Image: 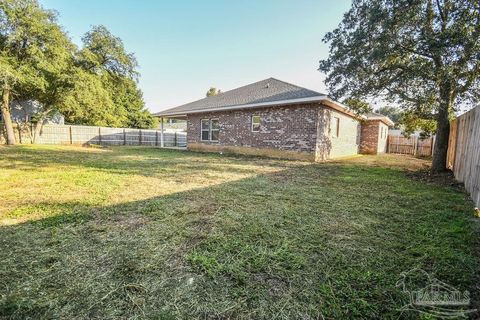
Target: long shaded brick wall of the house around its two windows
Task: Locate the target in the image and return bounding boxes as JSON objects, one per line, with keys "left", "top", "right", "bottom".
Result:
{"left": 187, "top": 104, "right": 319, "bottom": 153}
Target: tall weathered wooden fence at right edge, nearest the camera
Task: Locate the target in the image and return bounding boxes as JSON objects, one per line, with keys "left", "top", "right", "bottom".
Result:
{"left": 447, "top": 106, "right": 480, "bottom": 207}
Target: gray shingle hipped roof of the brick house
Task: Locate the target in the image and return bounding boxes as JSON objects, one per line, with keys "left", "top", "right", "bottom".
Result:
{"left": 154, "top": 78, "right": 325, "bottom": 116}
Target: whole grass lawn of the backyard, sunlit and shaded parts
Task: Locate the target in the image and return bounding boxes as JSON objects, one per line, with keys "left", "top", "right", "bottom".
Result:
{"left": 0, "top": 146, "right": 480, "bottom": 319}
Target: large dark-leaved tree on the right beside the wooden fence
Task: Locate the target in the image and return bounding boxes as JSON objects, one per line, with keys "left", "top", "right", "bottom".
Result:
{"left": 319, "top": 0, "right": 480, "bottom": 172}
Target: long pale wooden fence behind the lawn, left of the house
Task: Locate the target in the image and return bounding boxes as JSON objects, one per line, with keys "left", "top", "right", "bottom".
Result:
{"left": 0, "top": 125, "right": 187, "bottom": 147}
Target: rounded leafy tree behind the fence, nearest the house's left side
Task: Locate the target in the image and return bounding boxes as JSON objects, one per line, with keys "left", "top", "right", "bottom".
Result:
{"left": 66, "top": 26, "right": 155, "bottom": 128}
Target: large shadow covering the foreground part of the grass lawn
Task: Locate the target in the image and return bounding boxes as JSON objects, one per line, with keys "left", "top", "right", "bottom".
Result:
{"left": 0, "top": 164, "right": 478, "bottom": 319}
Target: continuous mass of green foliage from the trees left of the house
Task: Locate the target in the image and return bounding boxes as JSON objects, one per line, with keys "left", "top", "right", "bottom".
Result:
{"left": 0, "top": 0, "right": 155, "bottom": 128}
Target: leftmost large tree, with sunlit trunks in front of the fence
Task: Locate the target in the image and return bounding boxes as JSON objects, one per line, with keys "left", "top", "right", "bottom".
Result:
{"left": 0, "top": 0, "right": 75, "bottom": 143}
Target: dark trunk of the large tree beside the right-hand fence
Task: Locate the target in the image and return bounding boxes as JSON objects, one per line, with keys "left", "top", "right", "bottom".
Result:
{"left": 432, "top": 88, "right": 453, "bottom": 173}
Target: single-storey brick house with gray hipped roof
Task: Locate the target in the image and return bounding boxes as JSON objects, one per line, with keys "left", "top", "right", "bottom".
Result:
{"left": 154, "top": 78, "right": 393, "bottom": 161}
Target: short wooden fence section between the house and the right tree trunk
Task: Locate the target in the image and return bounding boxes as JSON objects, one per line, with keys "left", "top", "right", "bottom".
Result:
{"left": 387, "top": 135, "right": 435, "bottom": 156}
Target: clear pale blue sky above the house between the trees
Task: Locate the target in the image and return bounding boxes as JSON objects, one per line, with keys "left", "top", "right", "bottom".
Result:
{"left": 40, "top": 0, "right": 351, "bottom": 112}
